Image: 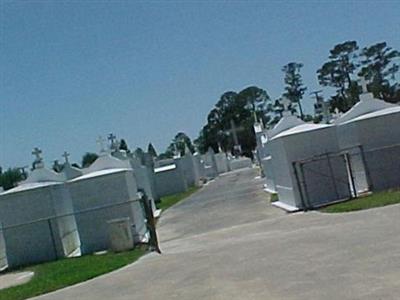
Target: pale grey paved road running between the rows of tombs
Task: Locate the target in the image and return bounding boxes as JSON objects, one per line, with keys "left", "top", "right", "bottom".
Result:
{"left": 32, "top": 170, "right": 400, "bottom": 300}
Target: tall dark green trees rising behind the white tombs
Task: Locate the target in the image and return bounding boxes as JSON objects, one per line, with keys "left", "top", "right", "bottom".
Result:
{"left": 195, "top": 41, "right": 400, "bottom": 157}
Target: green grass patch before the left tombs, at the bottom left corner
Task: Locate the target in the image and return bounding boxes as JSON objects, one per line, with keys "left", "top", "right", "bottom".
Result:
{"left": 0, "top": 249, "right": 146, "bottom": 300}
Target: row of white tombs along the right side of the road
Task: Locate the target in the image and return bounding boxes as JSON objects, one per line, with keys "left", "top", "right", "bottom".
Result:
{"left": 254, "top": 87, "right": 400, "bottom": 211}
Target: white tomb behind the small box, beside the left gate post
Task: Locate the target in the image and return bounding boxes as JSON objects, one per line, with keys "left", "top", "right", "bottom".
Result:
{"left": 68, "top": 152, "right": 148, "bottom": 254}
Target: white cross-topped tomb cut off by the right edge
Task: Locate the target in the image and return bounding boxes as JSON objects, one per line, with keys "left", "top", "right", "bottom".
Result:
{"left": 335, "top": 81, "right": 400, "bottom": 193}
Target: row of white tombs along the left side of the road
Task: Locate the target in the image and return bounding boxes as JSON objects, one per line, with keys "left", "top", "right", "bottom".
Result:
{"left": 0, "top": 144, "right": 252, "bottom": 271}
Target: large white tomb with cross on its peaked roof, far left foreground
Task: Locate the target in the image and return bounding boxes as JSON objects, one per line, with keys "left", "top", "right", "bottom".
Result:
{"left": 0, "top": 149, "right": 80, "bottom": 267}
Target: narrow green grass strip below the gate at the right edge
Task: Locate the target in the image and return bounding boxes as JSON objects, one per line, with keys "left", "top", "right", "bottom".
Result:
{"left": 320, "top": 190, "right": 400, "bottom": 213}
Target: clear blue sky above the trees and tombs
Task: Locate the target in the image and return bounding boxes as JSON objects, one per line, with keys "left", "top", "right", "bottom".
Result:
{"left": 0, "top": 1, "right": 400, "bottom": 167}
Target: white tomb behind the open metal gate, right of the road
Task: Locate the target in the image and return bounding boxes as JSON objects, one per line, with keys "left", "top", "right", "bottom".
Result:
{"left": 269, "top": 124, "right": 349, "bottom": 209}
